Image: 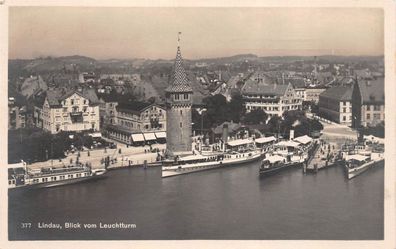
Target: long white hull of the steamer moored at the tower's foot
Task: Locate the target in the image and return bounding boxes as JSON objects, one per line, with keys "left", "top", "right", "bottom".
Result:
{"left": 162, "top": 153, "right": 261, "bottom": 178}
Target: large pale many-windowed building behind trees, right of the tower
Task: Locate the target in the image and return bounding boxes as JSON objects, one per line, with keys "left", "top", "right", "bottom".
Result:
{"left": 242, "top": 74, "right": 302, "bottom": 117}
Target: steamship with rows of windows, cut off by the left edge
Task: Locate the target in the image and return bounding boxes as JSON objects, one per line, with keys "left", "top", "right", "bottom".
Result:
{"left": 8, "top": 161, "right": 106, "bottom": 190}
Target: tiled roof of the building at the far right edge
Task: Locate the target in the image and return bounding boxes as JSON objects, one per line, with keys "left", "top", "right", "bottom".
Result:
{"left": 358, "top": 78, "right": 385, "bottom": 104}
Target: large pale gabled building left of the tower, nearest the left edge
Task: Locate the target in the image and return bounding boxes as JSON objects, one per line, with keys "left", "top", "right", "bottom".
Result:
{"left": 33, "top": 88, "right": 100, "bottom": 134}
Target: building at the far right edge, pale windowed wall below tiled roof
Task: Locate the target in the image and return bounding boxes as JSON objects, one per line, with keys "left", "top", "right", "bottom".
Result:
{"left": 359, "top": 77, "right": 385, "bottom": 126}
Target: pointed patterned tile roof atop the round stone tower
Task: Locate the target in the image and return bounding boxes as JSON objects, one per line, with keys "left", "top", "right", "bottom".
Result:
{"left": 165, "top": 46, "right": 193, "bottom": 92}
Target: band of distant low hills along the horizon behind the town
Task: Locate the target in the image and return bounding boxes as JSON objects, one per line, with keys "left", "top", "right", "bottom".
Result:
{"left": 9, "top": 54, "right": 384, "bottom": 75}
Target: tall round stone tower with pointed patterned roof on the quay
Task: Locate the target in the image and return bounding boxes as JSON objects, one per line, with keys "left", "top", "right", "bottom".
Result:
{"left": 165, "top": 42, "right": 193, "bottom": 156}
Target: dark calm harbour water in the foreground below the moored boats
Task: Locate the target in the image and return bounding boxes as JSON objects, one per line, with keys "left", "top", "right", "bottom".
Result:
{"left": 8, "top": 163, "right": 384, "bottom": 240}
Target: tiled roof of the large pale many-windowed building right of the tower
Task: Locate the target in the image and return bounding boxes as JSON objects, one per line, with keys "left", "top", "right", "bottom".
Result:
{"left": 242, "top": 79, "right": 289, "bottom": 96}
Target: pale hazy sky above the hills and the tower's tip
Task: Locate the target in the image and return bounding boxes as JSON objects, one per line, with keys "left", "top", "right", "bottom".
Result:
{"left": 9, "top": 7, "right": 384, "bottom": 59}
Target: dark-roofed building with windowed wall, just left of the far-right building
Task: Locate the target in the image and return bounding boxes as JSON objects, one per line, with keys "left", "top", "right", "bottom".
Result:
{"left": 318, "top": 86, "right": 352, "bottom": 126}
